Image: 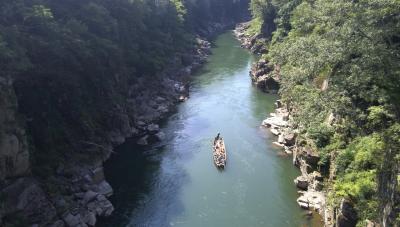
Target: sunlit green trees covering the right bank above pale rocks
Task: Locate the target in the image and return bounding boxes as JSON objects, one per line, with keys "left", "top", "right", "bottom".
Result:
{"left": 250, "top": 0, "right": 400, "bottom": 226}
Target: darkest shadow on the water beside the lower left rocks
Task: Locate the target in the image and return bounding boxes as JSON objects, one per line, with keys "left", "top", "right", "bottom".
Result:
{"left": 98, "top": 140, "right": 161, "bottom": 227}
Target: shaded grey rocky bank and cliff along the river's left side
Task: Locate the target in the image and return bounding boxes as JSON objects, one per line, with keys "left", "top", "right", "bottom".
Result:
{"left": 0, "top": 38, "right": 210, "bottom": 226}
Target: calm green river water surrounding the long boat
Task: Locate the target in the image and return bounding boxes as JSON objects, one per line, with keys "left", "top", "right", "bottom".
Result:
{"left": 101, "top": 32, "right": 321, "bottom": 227}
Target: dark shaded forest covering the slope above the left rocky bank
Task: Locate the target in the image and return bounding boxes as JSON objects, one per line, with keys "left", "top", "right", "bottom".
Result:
{"left": 0, "top": 0, "right": 246, "bottom": 174}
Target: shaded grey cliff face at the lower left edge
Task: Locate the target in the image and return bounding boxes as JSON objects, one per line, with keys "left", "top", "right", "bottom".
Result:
{"left": 0, "top": 76, "right": 56, "bottom": 226}
